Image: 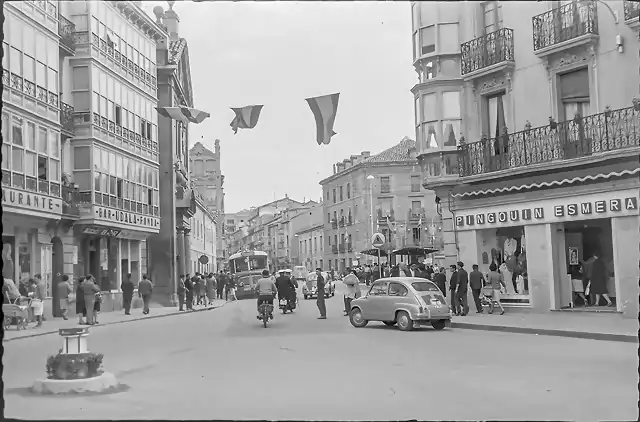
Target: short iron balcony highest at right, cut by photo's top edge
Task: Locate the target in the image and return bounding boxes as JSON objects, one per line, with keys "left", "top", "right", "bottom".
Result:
{"left": 532, "top": 0, "right": 598, "bottom": 56}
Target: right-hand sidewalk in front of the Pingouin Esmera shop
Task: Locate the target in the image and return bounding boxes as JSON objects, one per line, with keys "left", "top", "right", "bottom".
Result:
{"left": 360, "top": 283, "right": 639, "bottom": 343}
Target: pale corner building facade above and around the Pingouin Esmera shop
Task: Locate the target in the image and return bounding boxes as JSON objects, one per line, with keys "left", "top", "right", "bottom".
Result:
{"left": 412, "top": 0, "right": 640, "bottom": 318}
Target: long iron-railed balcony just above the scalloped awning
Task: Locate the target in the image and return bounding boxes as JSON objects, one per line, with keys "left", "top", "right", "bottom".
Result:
{"left": 458, "top": 107, "right": 640, "bottom": 177}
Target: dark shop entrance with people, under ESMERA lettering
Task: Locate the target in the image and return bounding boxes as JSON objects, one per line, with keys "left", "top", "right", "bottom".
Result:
{"left": 563, "top": 218, "right": 616, "bottom": 312}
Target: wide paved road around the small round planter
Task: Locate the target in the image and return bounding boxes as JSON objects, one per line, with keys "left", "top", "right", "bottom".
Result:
{"left": 3, "top": 297, "right": 638, "bottom": 421}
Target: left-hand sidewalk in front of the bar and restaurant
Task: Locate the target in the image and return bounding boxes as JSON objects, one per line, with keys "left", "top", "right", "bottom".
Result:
{"left": 3, "top": 299, "right": 226, "bottom": 342}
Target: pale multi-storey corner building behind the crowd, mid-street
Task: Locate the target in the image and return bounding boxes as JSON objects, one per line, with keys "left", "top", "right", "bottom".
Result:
{"left": 320, "top": 137, "right": 440, "bottom": 271}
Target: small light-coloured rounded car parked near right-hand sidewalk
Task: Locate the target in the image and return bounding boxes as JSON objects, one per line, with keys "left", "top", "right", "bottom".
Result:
{"left": 349, "top": 277, "right": 452, "bottom": 331}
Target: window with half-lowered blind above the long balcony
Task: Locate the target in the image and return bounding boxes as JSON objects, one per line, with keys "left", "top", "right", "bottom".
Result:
{"left": 558, "top": 68, "right": 590, "bottom": 121}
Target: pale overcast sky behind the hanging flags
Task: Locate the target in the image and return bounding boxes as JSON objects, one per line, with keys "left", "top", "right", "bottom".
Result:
{"left": 144, "top": 1, "right": 417, "bottom": 213}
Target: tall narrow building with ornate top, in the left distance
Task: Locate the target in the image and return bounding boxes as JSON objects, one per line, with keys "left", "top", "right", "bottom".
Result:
{"left": 189, "top": 139, "right": 227, "bottom": 265}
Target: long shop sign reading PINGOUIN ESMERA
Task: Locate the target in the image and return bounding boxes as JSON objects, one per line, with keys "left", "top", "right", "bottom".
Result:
{"left": 455, "top": 192, "right": 638, "bottom": 229}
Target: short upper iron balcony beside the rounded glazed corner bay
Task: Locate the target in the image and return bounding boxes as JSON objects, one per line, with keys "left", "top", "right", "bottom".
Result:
{"left": 460, "top": 28, "right": 515, "bottom": 80}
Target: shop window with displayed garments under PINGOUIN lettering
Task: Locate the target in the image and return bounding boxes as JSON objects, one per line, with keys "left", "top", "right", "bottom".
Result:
{"left": 478, "top": 226, "right": 529, "bottom": 304}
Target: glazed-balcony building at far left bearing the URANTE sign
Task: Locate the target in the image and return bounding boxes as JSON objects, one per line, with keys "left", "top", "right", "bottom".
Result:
{"left": 2, "top": 2, "right": 79, "bottom": 316}
